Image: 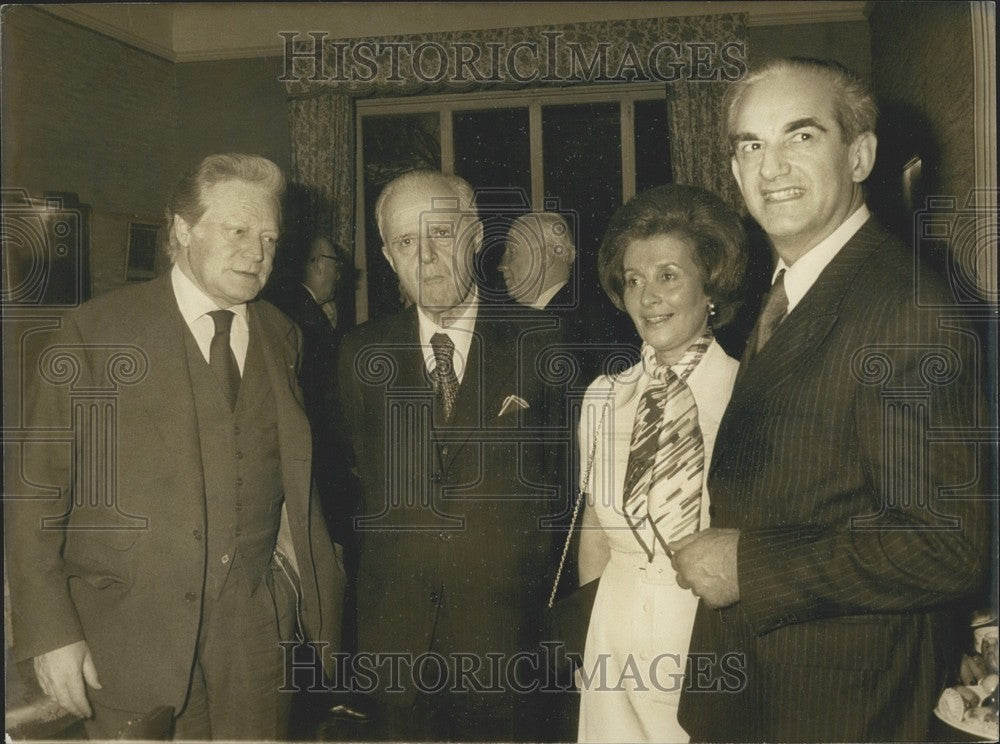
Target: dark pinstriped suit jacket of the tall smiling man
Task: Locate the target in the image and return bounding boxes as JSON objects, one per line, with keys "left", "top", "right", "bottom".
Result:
{"left": 680, "top": 218, "right": 989, "bottom": 741}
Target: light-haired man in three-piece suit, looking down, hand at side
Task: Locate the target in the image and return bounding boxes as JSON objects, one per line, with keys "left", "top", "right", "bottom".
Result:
{"left": 5, "top": 154, "right": 344, "bottom": 739}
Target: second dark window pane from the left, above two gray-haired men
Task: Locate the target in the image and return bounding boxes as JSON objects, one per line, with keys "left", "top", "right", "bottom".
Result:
{"left": 452, "top": 107, "right": 531, "bottom": 296}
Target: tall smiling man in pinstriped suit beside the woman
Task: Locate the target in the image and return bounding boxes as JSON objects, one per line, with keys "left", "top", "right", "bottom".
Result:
{"left": 671, "top": 59, "right": 989, "bottom": 741}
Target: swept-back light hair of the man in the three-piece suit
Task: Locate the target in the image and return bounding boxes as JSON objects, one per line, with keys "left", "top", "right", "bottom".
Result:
{"left": 166, "top": 152, "right": 285, "bottom": 262}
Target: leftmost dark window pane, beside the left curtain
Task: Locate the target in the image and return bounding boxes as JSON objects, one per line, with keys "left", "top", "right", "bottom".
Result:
{"left": 361, "top": 112, "right": 441, "bottom": 318}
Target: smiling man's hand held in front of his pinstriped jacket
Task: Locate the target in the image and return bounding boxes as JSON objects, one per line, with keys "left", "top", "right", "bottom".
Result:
{"left": 667, "top": 527, "right": 740, "bottom": 609}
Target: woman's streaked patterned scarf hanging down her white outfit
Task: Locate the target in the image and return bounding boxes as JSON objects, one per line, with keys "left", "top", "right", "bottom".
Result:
{"left": 623, "top": 335, "right": 712, "bottom": 560}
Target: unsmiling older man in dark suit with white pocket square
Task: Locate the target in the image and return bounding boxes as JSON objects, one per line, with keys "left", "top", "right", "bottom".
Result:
{"left": 339, "top": 171, "right": 567, "bottom": 741}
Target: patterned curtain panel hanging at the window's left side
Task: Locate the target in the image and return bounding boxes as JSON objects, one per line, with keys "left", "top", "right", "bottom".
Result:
{"left": 289, "top": 93, "right": 355, "bottom": 250}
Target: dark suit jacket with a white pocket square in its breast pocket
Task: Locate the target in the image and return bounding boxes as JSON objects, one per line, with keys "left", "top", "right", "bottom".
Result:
{"left": 339, "top": 305, "right": 572, "bottom": 705}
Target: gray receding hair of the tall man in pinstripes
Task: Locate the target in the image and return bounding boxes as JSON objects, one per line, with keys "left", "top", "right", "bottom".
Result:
{"left": 722, "top": 57, "right": 878, "bottom": 147}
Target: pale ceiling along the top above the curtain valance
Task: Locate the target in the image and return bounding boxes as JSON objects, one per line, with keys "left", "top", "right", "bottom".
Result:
{"left": 36, "top": 0, "right": 867, "bottom": 62}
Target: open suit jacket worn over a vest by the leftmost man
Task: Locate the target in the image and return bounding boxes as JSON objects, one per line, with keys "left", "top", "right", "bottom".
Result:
{"left": 5, "top": 275, "right": 344, "bottom": 710}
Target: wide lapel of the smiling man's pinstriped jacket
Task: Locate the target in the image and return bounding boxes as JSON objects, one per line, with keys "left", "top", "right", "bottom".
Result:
{"left": 733, "top": 218, "right": 885, "bottom": 398}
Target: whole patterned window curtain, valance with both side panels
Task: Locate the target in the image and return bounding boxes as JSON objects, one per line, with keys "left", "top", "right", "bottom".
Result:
{"left": 282, "top": 14, "right": 749, "bottom": 296}
